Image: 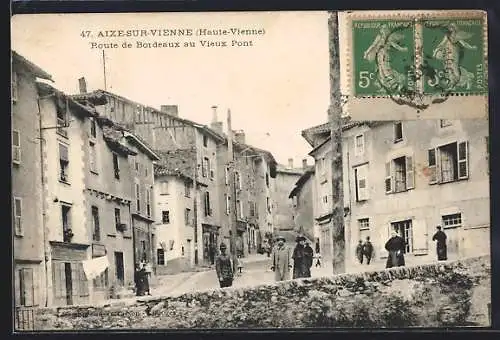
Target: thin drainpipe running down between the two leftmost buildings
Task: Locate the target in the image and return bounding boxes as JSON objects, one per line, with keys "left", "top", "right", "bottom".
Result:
{"left": 37, "top": 93, "right": 54, "bottom": 307}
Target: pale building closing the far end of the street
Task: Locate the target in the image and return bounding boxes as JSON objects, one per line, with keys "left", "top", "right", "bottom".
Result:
{"left": 270, "top": 158, "right": 304, "bottom": 231}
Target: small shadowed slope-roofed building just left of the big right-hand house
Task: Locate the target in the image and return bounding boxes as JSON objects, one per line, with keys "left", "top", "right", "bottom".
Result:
{"left": 288, "top": 160, "right": 319, "bottom": 243}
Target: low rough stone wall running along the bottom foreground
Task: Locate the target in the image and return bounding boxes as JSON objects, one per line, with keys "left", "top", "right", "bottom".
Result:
{"left": 35, "top": 257, "right": 490, "bottom": 330}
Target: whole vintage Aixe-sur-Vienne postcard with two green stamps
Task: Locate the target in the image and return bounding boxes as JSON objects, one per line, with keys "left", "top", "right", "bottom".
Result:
{"left": 11, "top": 11, "right": 491, "bottom": 332}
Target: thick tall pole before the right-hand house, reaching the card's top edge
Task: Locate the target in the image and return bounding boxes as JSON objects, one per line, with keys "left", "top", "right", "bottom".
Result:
{"left": 328, "top": 12, "right": 345, "bottom": 274}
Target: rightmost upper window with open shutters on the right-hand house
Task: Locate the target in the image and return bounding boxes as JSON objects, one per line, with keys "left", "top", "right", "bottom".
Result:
{"left": 428, "top": 142, "right": 469, "bottom": 184}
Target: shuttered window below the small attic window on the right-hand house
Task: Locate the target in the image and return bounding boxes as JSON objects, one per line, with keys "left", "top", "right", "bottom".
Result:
{"left": 385, "top": 156, "right": 415, "bottom": 193}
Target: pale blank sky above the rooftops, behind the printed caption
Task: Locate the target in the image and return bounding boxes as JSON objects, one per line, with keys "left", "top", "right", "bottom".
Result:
{"left": 11, "top": 12, "right": 329, "bottom": 167}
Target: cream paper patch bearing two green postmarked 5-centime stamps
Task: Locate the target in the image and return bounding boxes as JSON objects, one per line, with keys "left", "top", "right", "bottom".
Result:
{"left": 339, "top": 10, "right": 488, "bottom": 119}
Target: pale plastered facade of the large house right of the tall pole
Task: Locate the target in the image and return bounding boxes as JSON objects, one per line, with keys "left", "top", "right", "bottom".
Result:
{"left": 343, "top": 120, "right": 490, "bottom": 267}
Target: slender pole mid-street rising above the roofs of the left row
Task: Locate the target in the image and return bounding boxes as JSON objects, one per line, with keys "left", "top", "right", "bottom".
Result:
{"left": 227, "top": 109, "right": 238, "bottom": 272}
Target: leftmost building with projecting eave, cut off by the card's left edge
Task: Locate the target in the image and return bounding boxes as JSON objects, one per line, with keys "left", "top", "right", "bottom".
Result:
{"left": 11, "top": 52, "right": 52, "bottom": 307}
